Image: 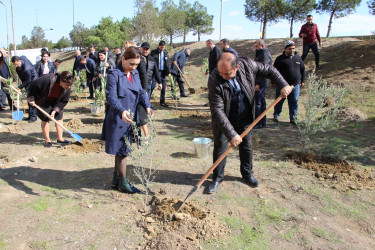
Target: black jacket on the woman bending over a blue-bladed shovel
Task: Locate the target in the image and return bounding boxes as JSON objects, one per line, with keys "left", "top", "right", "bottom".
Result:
{"left": 27, "top": 74, "right": 71, "bottom": 113}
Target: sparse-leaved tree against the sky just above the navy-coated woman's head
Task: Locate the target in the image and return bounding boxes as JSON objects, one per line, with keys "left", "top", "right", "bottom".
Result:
{"left": 133, "top": 0, "right": 161, "bottom": 42}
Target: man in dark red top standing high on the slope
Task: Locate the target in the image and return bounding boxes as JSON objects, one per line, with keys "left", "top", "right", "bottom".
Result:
{"left": 299, "top": 15, "right": 322, "bottom": 69}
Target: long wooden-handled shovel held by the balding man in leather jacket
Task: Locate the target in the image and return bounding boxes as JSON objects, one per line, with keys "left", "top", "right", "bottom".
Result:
{"left": 177, "top": 86, "right": 294, "bottom": 213}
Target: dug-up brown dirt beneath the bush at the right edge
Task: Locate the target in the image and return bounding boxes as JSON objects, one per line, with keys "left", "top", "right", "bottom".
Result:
{"left": 286, "top": 151, "right": 375, "bottom": 191}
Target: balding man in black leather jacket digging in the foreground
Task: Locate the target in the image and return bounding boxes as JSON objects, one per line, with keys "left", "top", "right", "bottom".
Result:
{"left": 208, "top": 52, "right": 292, "bottom": 194}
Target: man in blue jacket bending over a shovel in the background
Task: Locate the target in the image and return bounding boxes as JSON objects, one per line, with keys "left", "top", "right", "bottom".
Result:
{"left": 171, "top": 49, "right": 191, "bottom": 99}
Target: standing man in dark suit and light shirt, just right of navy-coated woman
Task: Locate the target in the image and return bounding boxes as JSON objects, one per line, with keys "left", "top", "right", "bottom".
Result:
{"left": 151, "top": 41, "right": 170, "bottom": 107}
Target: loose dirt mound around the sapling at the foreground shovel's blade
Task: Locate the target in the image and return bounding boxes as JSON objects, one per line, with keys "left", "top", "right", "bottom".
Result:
{"left": 140, "top": 197, "right": 229, "bottom": 249}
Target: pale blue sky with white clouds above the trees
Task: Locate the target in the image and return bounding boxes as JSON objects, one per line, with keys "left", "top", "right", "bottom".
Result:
{"left": 0, "top": 0, "right": 375, "bottom": 47}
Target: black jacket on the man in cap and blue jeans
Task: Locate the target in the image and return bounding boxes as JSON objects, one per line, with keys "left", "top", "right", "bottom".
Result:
{"left": 273, "top": 52, "right": 305, "bottom": 85}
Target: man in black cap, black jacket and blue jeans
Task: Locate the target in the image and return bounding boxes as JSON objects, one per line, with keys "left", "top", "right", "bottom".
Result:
{"left": 273, "top": 40, "right": 305, "bottom": 125}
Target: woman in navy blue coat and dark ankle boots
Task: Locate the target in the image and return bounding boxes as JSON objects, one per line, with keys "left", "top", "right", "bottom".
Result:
{"left": 102, "top": 47, "right": 153, "bottom": 193}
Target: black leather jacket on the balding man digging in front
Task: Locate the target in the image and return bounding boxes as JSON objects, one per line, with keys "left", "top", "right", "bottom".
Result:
{"left": 208, "top": 57, "right": 288, "bottom": 140}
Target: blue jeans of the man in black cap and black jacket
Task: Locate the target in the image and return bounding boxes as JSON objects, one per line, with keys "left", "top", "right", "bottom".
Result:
{"left": 273, "top": 84, "right": 300, "bottom": 121}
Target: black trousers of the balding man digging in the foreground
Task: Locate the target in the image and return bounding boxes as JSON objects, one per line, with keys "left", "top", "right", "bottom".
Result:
{"left": 212, "top": 122, "right": 253, "bottom": 182}
